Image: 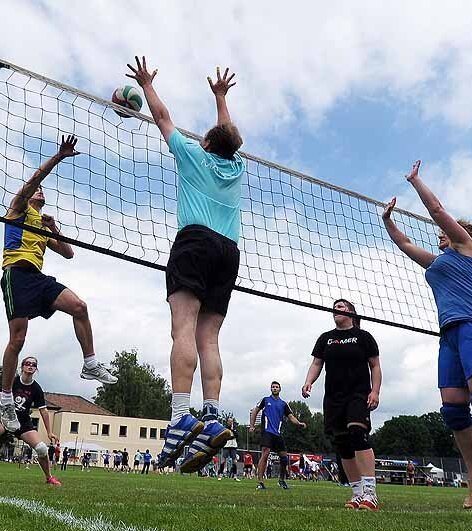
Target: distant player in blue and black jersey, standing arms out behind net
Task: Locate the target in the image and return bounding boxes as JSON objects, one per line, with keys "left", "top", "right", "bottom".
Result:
{"left": 249, "top": 381, "right": 306, "bottom": 490}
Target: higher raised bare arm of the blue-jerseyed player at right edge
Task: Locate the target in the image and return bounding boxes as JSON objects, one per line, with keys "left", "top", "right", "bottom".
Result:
{"left": 406, "top": 160, "right": 472, "bottom": 249}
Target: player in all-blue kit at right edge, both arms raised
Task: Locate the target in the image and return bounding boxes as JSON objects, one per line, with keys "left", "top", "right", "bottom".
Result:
{"left": 382, "top": 160, "right": 472, "bottom": 509}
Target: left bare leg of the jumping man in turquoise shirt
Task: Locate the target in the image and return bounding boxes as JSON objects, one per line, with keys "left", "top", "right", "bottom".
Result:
{"left": 169, "top": 291, "right": 201, "bottom": 393}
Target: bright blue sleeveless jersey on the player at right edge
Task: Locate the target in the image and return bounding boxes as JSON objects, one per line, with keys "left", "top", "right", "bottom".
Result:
{"left": 425, "top": 248, "right": 472, "bottom": 328}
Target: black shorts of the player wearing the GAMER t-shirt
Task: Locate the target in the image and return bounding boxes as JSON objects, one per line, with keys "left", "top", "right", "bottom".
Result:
{"left": 323, "top": 393, "right": 371, "bottom": 435}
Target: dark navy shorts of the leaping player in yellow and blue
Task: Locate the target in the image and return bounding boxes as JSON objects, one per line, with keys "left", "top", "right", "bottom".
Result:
{"left": 1, "top": 266, "right": 66, "bottom": 321}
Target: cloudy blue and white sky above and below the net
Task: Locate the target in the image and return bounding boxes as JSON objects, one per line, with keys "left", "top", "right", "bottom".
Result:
{"left": 0, "top": 0, "right": 472, "bottom": 432}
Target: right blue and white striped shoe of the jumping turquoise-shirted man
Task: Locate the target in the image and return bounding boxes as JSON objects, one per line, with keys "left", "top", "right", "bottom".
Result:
{"left": 180, "top": 422, "right": 234, "bottom": 474}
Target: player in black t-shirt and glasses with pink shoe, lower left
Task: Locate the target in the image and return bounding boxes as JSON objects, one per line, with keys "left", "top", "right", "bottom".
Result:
{"left": 0, "top": 356, "right": 61, "bottom": 486}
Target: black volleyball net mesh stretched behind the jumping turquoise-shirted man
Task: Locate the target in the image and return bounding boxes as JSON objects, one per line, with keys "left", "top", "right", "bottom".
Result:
{"left": 0, "top": 63, "right": 437, "bottom": 332}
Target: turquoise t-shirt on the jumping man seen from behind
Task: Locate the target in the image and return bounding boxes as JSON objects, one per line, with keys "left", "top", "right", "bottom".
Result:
{"left": 169, "top": 129, "right": 244, "bottom": 243}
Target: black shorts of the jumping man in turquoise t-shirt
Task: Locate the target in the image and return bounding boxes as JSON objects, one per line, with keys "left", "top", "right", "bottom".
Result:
{"left": 166, "top": 225, "right": 239, "bottom": 316}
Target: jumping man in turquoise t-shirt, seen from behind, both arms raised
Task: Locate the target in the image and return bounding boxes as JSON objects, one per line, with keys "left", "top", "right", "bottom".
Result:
{"left": 127, "top": 57, "right": 244, "bottom": 472}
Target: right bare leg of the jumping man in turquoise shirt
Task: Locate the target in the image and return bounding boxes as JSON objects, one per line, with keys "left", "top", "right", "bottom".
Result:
{"left": 196, "top": 312, "right": 224, "bottom": 400}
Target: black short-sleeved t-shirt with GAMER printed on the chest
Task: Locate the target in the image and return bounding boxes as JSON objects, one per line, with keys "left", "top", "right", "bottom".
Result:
{"left": 312, "top": 327, "right": 379, "bottom": 398}
